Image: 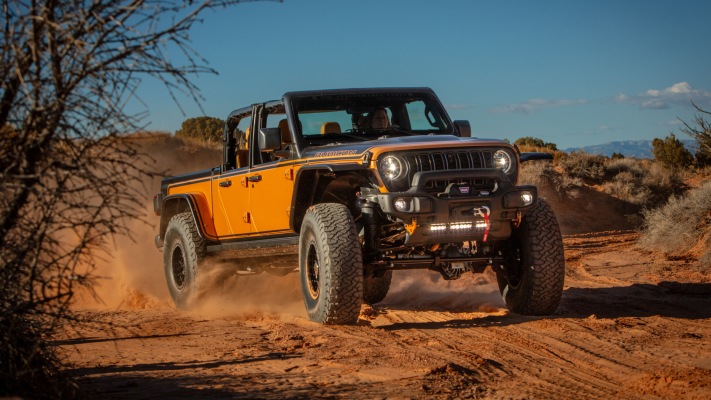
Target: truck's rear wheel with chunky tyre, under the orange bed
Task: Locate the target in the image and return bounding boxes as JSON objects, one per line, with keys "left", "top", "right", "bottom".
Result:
{"left": 163, "top": 212, "right": 205, "bottom": 309}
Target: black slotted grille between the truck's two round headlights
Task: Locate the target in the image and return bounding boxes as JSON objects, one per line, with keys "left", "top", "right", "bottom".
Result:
{"left": 402, "top": 150, "right": 495, "bottom": 193}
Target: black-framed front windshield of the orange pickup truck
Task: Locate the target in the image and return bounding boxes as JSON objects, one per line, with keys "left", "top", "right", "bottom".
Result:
{"left": 294, "top": 93, "right": 452, "bottom": 142}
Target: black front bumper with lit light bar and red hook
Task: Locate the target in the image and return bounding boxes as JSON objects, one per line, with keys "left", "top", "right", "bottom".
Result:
{"left": 366, "top": 169, "right": 538, "bottom": 245}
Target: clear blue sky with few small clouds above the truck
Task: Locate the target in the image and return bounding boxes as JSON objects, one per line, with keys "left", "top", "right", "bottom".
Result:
{"left": 139, "top": 0, "right": 711, "bottom": 148}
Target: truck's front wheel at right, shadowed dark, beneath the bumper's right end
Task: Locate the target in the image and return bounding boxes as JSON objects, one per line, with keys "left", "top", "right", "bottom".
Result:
{"left": 497, "top": 199, "right": 565, "bottom": 315}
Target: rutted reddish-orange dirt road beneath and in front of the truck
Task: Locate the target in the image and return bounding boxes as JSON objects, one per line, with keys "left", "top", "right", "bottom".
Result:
{"left": 60, "top": 232, "right": 711, "bottom": 399}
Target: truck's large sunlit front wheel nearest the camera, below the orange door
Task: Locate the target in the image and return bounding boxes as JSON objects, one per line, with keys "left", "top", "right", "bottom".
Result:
{"left": 299, "top": 203, "right": 363, "bottom": 324}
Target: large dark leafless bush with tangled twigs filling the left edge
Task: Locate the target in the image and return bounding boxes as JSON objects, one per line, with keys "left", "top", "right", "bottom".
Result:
{"left": 0, "top": 0, "right": 253, "bottom": 398}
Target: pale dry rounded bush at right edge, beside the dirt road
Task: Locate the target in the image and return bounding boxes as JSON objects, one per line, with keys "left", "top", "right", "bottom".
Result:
{"left": 639, "top": 181, "right": 711, "bottom": 269}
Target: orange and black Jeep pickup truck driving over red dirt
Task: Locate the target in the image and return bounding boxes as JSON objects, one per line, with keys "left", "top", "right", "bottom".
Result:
{"left": 154, "top": 88, "right": 565, "bottom": 324}
